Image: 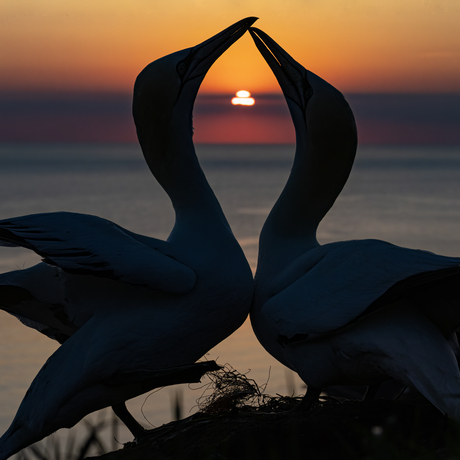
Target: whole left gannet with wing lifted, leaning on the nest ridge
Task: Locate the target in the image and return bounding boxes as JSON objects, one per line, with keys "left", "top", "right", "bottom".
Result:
{"left": 0, "top": 18, "right": 256, "bottom": 460}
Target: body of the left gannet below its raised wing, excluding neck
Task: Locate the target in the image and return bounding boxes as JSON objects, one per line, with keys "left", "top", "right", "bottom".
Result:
{"left": 0, "top": 226, "right": 246, "bottom": 424}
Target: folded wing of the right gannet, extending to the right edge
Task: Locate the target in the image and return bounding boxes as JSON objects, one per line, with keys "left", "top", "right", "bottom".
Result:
{"left": 263, "top": 240, "right": 460, "bottom": 340}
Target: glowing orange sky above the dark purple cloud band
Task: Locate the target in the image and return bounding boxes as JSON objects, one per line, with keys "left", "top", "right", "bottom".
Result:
{"left": 0, "top": 0, "right": 460, "bottom": 94}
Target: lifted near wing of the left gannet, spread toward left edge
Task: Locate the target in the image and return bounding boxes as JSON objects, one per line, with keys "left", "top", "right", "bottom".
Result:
{"left": 0, "top": 212, "right": 196, "bottom": 294}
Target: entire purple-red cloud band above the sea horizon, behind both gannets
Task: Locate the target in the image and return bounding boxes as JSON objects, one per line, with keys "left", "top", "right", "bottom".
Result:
{"left": 0, "top": 93, "right": 460, "bottom": 144}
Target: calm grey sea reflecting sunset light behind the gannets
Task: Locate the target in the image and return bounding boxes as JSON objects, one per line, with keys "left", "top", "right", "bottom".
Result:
{"left": 0, "top": 144, "right": 460, "bottom": 458}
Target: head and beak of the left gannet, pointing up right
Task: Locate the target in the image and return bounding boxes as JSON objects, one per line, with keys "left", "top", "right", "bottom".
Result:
{"left": 133, "top": 17, "right": 257, "bottom": 155}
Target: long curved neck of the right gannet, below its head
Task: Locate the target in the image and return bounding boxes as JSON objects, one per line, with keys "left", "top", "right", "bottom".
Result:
{"left": 258, "top": 108, "right": 354, "bottom": 271}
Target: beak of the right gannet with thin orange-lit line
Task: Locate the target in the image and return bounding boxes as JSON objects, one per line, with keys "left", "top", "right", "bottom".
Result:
{"left": 249, "top": 27, "right": 312, "bottom": 111}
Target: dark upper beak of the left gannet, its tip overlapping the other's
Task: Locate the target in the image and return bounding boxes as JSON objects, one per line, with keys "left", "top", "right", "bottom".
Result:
{"left": 182, "top": 17, "right": 258, "bottom": 83}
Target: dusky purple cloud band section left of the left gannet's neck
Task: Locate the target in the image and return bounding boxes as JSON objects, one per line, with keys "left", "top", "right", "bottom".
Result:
{"left": 0, "top": 93, "right": 136, "bottom": 142}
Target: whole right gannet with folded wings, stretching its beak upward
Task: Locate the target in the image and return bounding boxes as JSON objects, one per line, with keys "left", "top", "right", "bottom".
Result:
{"left": 250, "top": 28, "right": 460, "bottom": 420}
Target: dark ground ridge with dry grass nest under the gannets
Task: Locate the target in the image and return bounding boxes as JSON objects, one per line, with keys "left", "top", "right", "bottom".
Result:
{"left": 83, "top": 368, "right": 460, "bottom": 460}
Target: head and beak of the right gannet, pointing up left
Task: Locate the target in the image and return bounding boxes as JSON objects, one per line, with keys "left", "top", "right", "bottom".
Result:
{"left": 249, "top": 28, "right": 357, "bottom": 162}
